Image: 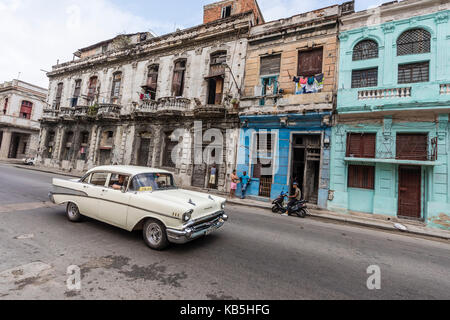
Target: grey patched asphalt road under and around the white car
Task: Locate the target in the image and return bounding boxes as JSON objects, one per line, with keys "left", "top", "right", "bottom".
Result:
{"left": 0, "top": 165, "right": 450, "bottom": 300}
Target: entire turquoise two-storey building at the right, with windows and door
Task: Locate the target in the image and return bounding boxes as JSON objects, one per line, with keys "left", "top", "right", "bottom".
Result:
{"left": 328, "top": 0, "right": 450, "bottom": 229}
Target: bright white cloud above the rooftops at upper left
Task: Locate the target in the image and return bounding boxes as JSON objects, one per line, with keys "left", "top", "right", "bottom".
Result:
{"left": 0, "top": 0, "right": 173, "bottom": 87}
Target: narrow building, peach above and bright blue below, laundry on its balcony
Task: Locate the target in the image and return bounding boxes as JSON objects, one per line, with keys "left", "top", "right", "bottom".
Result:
{"left": 238, "top": 1, "right": 354, "bottom": 207}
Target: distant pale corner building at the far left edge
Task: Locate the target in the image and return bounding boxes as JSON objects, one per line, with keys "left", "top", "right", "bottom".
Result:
{"left": 0, "top": 80, "right": 47, "bottom": 159}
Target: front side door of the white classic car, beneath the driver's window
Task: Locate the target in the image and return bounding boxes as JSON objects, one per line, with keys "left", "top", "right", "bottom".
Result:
{"left": 98, "top": 173, "right": 130, "bottom": 228}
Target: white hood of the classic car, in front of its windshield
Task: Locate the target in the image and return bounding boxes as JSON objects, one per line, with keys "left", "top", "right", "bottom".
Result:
{"left": 142, "top": 189, "right": 226, "bottom": 219}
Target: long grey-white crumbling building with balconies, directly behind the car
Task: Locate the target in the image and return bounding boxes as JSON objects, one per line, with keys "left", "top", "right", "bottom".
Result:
{"left": 40, "top": 0, "right": 260, "bottom": 190}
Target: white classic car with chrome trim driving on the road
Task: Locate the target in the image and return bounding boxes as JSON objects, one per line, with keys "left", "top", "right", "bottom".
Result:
{"left": 49, "top": 166, "right": 228, "bottom": 250}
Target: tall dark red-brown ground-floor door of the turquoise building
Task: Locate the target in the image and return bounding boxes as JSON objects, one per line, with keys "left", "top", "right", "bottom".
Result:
{"left": 398, "top": 167, "right": 422, "bottom": 219}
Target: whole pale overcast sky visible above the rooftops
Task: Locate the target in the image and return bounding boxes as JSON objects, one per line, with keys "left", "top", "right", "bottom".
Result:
{"left": 0, "top": 0, "right": 386, "bottom": 88}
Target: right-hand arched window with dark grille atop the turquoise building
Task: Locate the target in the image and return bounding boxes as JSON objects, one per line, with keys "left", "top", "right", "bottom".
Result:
{"left": 397, "top": 29, "right": 431, "bottom": 56}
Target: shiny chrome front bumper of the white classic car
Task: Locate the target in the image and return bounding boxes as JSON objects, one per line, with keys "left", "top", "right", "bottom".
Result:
{"left": 167, "top": 211, "right": 228, "bottom": 244}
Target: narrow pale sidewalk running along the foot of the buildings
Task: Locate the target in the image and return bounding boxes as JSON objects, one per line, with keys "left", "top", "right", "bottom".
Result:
{"left": 7, "top": 165, "right": 450, "bottom": 240}
